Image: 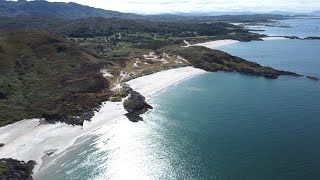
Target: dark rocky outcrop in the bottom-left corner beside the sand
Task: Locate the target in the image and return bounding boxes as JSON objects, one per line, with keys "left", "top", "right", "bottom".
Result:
{"left": 0, "top": 159, "right": 36, "bottom": 180}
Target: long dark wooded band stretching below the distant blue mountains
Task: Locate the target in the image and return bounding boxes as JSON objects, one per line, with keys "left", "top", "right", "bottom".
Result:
{"left": 0, "top": 16, "right": 251, "bottom": 37}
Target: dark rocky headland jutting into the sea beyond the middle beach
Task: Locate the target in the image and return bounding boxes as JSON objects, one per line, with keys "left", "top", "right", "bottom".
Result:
{"left": 166, "top": 45, "right": 302, "bottom": 79}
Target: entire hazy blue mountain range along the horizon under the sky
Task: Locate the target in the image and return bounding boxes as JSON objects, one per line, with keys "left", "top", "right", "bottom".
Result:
{"left": 0, "top": 0, "right": 287, "bottom": 23}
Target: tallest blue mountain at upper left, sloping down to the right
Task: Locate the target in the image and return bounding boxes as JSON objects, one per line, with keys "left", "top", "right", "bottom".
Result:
{"left": 0, "top": 0, "right": 142, "bottom": 19}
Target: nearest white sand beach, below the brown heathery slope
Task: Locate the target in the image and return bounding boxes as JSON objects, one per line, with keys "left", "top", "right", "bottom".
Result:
{"left": 0, "top": 102, "right": 126, "bottom": 172}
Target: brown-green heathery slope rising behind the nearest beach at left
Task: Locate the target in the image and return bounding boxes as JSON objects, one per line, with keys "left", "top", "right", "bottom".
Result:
{"left": 0, "top": 31, "right": 108, "bottom": 126}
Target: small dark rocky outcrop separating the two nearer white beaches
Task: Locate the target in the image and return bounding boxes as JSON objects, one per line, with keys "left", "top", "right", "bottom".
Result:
{"left": 123, "top": 87, "right": 153, "bottom": 122}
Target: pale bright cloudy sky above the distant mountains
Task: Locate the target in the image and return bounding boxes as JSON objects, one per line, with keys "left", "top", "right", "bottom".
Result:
{"left": 48, "top": 0, "right": 320, "bottom": 14}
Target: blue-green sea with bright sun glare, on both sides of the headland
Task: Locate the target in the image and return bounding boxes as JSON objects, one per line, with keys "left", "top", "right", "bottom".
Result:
{"left": 36, "top": 17, "right": 320, "bottom": 180}
